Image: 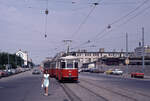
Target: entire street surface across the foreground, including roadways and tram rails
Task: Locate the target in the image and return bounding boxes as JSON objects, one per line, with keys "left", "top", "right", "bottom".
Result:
{"left": 0, "top": 71, "right": 150, "bottom": 101}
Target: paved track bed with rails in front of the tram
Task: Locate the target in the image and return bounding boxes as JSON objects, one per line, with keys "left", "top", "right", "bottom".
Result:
{"left": 60, "top": 79, "right": 150, "bottom": 101}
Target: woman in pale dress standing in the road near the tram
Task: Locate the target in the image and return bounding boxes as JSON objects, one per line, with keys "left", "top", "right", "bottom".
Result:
{"left": 42, "top": 70, "right": 49, "bottom": 96}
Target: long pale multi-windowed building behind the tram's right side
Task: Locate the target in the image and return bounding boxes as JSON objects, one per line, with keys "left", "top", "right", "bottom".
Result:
{"left": 71, "top": 48, "right": 133, "bottom": 67}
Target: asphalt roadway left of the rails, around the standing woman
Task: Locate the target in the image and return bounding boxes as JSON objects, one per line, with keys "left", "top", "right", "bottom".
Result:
{"left": 0, "top": 71, "right": 68, "bottom": 101}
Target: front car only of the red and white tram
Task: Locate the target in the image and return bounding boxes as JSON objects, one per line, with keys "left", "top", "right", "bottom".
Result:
{"left": 56, "top": 56, "right": 78, "bottom": 81}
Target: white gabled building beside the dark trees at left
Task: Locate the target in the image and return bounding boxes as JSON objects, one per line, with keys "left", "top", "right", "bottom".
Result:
{"left": 16, "top": 50, "right": 28, "bottom": 66}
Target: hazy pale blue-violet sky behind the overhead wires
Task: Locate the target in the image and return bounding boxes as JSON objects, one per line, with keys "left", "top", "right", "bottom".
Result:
{"left": 0, "top": 0, "right": 150, "bottom": 64}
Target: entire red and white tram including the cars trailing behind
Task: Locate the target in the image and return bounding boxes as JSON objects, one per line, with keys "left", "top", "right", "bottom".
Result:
{"left": 44, "top": 56, "right": 78, "bottom": 81}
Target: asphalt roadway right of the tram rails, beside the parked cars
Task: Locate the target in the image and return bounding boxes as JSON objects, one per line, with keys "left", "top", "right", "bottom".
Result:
{"left": 80, "top": 73, "right": 150, "bottom": 93}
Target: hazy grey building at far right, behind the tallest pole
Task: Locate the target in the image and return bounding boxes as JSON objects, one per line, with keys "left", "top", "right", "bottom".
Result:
{"left": 134, "top": 44, "right": 150, "bottom": 57}
